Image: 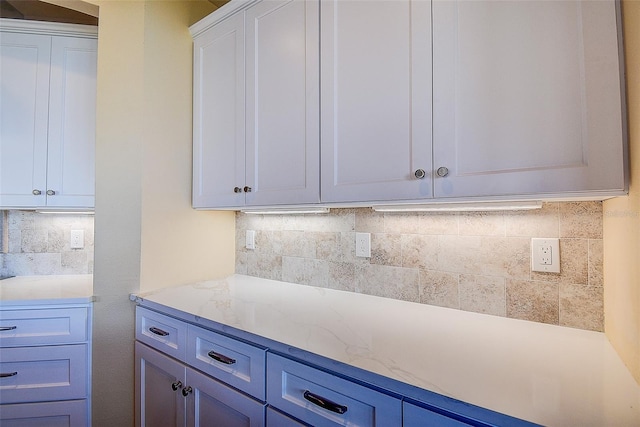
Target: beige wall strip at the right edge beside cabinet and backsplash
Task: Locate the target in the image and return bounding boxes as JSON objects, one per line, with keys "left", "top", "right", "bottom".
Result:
{"left": 604, "top": 1, "right": 640, "bottom": 383}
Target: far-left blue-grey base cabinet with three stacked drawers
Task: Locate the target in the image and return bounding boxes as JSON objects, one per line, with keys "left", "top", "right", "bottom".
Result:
{"left": 0, "top": 304, "right": 91, "bottom": 427}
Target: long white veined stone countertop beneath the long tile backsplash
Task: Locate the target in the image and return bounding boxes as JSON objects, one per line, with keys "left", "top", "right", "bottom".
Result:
{"left": 132, "top": 275, "right": 640, "bottom": 426}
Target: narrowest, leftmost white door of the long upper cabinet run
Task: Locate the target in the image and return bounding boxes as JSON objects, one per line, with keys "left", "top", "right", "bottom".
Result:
{"left": 192, "top": 12, "right": 245, "bottom": 208}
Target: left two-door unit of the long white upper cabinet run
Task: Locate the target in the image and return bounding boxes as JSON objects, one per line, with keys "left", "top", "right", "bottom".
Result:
{"left": 191, "top": 0, "right": 319, "bottom": 208}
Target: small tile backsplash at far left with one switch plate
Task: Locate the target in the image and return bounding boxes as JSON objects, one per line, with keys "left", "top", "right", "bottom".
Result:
{"left": 0, "top": 210, "right": 93, "bottom": 276}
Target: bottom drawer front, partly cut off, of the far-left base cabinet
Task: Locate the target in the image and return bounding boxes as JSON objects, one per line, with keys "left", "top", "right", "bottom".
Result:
{"left": 0, "top": 400, "right": 90, "bottom": 427}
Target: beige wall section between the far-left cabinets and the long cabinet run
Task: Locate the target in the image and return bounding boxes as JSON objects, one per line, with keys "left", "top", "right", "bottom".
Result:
{"left": 91, "top": 0, "right": 235, "bottom": 427}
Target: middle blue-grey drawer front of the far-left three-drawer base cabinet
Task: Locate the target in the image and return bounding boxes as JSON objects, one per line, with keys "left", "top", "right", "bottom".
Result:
{"left": 0, "top": 344, "right": 88, "bottom": 404}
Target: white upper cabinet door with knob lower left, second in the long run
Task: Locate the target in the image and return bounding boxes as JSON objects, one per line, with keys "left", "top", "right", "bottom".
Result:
{"left": 245, "top": 0, "right": 320, "bottom": 205}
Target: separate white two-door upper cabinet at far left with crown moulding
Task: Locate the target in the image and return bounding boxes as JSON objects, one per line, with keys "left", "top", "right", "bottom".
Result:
{"left": 0, "top": 20, "right": 97, "bottom": 208}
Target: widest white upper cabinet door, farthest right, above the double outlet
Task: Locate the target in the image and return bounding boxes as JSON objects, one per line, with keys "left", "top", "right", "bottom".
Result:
{"left": 433, "top": 0, "right": 624, "bottom": 198}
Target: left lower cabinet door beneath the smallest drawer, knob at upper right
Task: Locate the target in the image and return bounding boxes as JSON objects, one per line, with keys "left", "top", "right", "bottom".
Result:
{"left": 135, "top": 342, "right": 186, "bottom": 427}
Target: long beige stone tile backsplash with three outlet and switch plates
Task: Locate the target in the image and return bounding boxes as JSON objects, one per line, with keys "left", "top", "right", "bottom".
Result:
{"left": 236, "top": 202, "right": 604, "bottom": 331}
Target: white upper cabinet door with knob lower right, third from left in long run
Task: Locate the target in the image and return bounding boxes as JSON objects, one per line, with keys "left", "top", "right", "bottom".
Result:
{"left": 320, "top": 0, "right": 432, "bottom": 202}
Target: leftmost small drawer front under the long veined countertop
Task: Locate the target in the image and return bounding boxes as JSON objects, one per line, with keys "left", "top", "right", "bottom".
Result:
{"left": 136, "top": 307, "right": 187, "bottom": 361}
